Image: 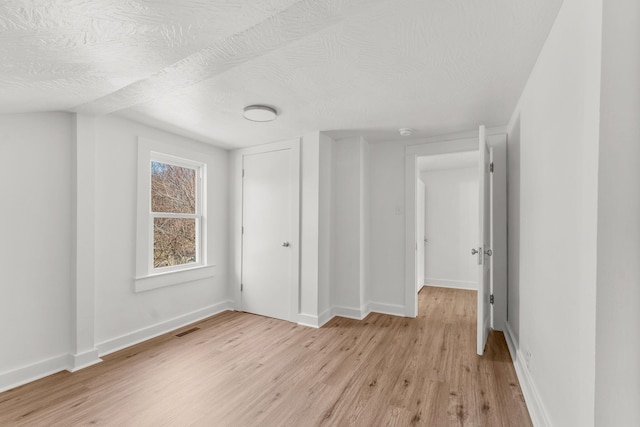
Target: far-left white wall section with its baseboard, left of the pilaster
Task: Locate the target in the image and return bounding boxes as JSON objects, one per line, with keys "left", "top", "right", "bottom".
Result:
{"left": 0, "top": 113, "right": 73, "bottom": 391}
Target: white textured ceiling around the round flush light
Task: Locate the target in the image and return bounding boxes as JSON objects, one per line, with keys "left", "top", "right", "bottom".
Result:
{"left": 0, "top": 0, "right": 562, "bottom": 147}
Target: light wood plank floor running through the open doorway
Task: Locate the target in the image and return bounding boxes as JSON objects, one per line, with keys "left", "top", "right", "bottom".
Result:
{"left": 0, "top": 287, "right": 531, "bottom": 427}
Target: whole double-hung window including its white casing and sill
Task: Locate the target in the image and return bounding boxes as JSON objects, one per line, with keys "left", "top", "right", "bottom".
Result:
{"left": 134, "top": 138, "right": 215, "bottom": 292}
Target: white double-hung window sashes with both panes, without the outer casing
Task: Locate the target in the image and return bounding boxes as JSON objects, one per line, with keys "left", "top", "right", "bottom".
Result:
{"left": 149, "top": 157, "right": 202, "bottom": 271}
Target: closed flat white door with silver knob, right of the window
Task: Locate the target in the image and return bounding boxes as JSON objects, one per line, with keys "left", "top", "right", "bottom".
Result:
{"left": 241, "top": 149, "right": 298, "bottom": 320}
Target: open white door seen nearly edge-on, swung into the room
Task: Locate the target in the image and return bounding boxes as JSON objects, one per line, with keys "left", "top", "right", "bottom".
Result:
{"left": 474, "top": 126, "right": 492, "bottom": 355}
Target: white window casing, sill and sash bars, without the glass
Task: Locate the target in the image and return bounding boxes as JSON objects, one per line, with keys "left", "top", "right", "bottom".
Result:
{"left": 134, "top": 137, "right": 215, "bottom": 292}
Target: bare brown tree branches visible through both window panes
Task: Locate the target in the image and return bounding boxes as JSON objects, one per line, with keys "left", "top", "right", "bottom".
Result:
{"left": 151, "top": 161, "right": 196, "bottom": 268}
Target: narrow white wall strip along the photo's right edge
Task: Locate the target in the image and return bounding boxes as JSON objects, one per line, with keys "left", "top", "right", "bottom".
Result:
{"left": 595, "top": 0, "right": 640, "bottom": 426}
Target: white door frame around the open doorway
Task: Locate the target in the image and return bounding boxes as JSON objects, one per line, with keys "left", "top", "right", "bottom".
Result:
{"left": 404, "top": 132, "right": 507, "bottom": 322}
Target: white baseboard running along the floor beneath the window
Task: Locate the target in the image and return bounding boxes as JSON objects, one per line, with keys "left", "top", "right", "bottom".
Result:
{"left": 96, "top": 301, "right": 234, "bottom": 356}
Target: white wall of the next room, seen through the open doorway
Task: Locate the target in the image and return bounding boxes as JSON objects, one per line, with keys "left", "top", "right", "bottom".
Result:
{"left": 418, "top": 167, "right": 479, "bottom": 289}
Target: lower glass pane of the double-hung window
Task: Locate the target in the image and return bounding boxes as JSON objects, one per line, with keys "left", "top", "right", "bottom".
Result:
{"left": 153, "top": 218, "right": 196, "bottom": 268}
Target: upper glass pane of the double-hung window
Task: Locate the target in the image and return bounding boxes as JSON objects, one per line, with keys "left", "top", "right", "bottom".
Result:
{"left": 151, "top": 161, "right": 196, "bottom": 214}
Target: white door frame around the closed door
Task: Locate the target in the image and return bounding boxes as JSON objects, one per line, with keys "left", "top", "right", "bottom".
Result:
{"left": 229, "top": 138, "right": 300, "bottom": 323}
